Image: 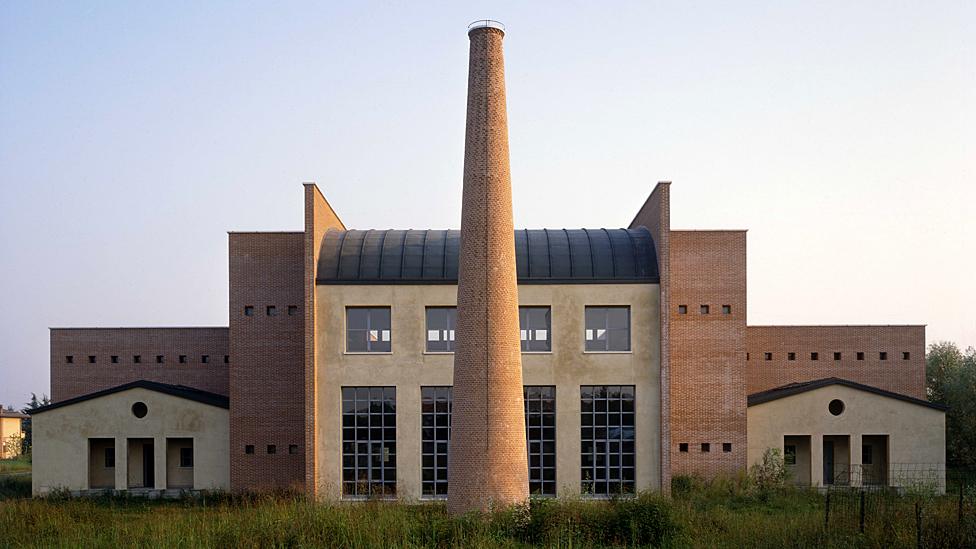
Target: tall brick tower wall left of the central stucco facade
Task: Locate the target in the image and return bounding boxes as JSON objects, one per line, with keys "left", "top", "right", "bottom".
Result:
{"left": 229, "top": 232, "right": 307, "bottom": 490}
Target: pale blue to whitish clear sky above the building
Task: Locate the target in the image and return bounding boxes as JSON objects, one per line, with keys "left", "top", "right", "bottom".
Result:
{"left": 0, "top": 0, "right": 976, "bottom": 407}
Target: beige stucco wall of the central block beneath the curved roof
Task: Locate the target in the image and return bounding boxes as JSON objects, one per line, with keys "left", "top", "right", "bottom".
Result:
{"left": 315, "top": 284, "right": 660, "bottom": 499}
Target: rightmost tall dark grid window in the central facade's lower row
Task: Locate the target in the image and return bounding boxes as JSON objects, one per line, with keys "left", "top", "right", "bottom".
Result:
{"left": 580, "top": 385, "right": 635, "bottom": 496}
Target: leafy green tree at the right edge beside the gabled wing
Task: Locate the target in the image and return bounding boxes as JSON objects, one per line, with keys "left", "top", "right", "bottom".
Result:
{"left": 925, "top": 341, "right": 976, "bottom": 469}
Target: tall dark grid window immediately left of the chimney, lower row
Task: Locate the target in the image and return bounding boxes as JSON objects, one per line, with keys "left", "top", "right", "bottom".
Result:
{"left": 420, "top": 387, "right": 451, "bottom": 497}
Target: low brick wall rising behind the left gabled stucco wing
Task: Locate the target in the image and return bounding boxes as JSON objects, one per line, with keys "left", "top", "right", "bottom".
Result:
{"left": 51, "top": 328, "right": 233, "bottom": 402}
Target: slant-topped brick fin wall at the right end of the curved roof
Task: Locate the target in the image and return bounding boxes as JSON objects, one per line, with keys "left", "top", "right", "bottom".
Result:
{"left": 630, "top": 181, "right": 671, "bottom": 493}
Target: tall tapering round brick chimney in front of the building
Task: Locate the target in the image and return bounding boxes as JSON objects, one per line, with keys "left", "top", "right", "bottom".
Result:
{"left": 447, "top": 21, "right": 528, "bottom": 514}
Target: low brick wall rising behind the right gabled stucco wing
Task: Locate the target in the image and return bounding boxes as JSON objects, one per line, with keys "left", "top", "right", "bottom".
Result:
{"left": 746, "top": 326, "right": 926, "bottom": 399}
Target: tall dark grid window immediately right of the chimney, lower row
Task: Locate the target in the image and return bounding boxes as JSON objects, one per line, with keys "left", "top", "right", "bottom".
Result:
{"left": 524, "top": 385, "right": 556, "bottom": 496}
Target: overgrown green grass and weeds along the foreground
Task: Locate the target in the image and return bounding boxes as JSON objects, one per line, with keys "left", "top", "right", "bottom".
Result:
{"left": 0, "top": 466, "right": 976, "bottom": 548}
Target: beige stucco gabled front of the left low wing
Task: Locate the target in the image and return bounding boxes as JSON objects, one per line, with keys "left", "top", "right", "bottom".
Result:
{"left": 32, "top": 388, "right": 230, "bottom": 495}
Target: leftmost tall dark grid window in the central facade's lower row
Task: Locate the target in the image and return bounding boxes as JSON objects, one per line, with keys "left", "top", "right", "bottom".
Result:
{"left": 342, "top": 387, "right": 396, "bottom": 496}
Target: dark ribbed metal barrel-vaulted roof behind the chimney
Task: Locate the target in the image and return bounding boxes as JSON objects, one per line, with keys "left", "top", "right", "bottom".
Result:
{"left": 316, "top": 227, "right": 659, "bottom": 284}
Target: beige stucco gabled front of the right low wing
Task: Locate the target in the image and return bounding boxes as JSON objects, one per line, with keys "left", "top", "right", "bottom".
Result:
{"left": 748, "top": 385, "right": 945, "bottom": 486}
